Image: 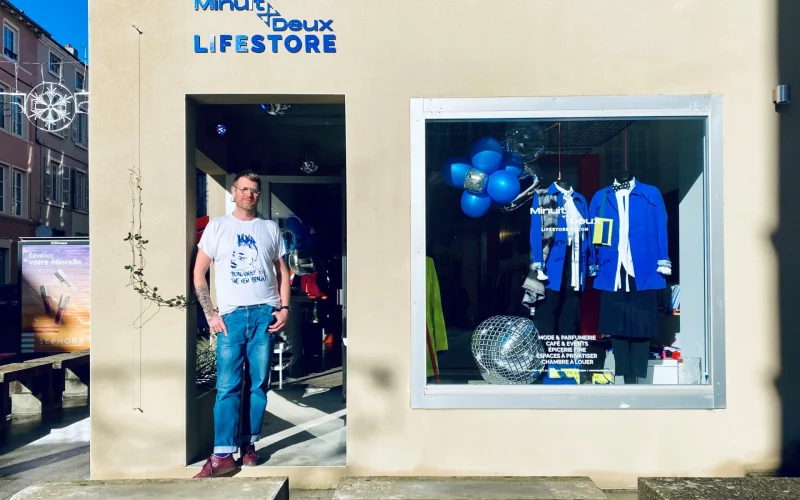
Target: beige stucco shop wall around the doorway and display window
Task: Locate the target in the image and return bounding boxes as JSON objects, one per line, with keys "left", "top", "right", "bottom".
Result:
{"left": 90, "top": 0, "right": 780, "bottom": 486}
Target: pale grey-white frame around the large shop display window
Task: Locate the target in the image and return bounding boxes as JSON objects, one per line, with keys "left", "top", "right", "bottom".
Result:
{"left": 410, "top": 95, "right": 726, "bottom": 410}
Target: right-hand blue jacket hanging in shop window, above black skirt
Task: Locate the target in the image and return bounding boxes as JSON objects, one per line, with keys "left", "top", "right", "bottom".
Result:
{"left": 589, "top": 180, "right": 672, "bottom": 292}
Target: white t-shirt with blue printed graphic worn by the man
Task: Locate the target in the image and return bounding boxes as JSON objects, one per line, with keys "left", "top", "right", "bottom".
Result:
{"left": 197, "top": 215, "right": 286, "bottom": 315}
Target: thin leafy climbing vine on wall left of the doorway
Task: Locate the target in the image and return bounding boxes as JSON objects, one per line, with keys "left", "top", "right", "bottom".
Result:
{"left": 124, "top": 167, "right": 188, "bottom": 310}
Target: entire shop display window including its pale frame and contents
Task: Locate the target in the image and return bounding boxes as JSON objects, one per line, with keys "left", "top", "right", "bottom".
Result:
{"left": 411, "top": 96, "right": 724, "bottom": 408}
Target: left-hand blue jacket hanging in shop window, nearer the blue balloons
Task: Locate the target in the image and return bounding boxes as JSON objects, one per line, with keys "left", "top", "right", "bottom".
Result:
{"left": 530, "top": 182, "right": 591, "bottom": 291}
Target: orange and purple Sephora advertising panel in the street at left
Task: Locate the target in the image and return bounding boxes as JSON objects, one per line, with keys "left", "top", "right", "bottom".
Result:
{"left": 19, "top": 239, "right": 90, "bottom": 354}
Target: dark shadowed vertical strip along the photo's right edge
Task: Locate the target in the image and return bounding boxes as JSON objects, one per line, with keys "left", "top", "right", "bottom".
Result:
{"left": 773, "top": 0, "right": 800, "bottom": 477}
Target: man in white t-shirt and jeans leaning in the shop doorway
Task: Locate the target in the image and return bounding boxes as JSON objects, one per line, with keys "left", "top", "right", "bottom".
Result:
{"left": 194, "top": 171, "right": 291, "bottom": 478}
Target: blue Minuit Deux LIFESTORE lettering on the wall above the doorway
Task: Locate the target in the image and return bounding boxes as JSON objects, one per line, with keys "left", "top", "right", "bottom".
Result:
{"left": 194, "top": 0, "right": 336, "bottom": 54}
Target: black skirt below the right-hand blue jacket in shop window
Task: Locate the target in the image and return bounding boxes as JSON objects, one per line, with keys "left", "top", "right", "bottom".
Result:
{"left": 597, "top": 266, "right": 658, "bottom": 339}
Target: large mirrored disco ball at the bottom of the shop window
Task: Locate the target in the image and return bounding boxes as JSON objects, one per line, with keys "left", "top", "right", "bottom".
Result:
{"left": 472, "top": 316, "right": 545, "bottom": 385}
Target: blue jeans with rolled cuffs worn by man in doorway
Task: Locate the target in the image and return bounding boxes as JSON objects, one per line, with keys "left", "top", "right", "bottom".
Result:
{"left": 214, "top": 304, "right": 275, "bottom": 453}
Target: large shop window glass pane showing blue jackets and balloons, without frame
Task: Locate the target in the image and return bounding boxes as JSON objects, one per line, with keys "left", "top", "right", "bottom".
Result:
{"left": 426, "top": 119, "right": 709, "bottom": 387}
